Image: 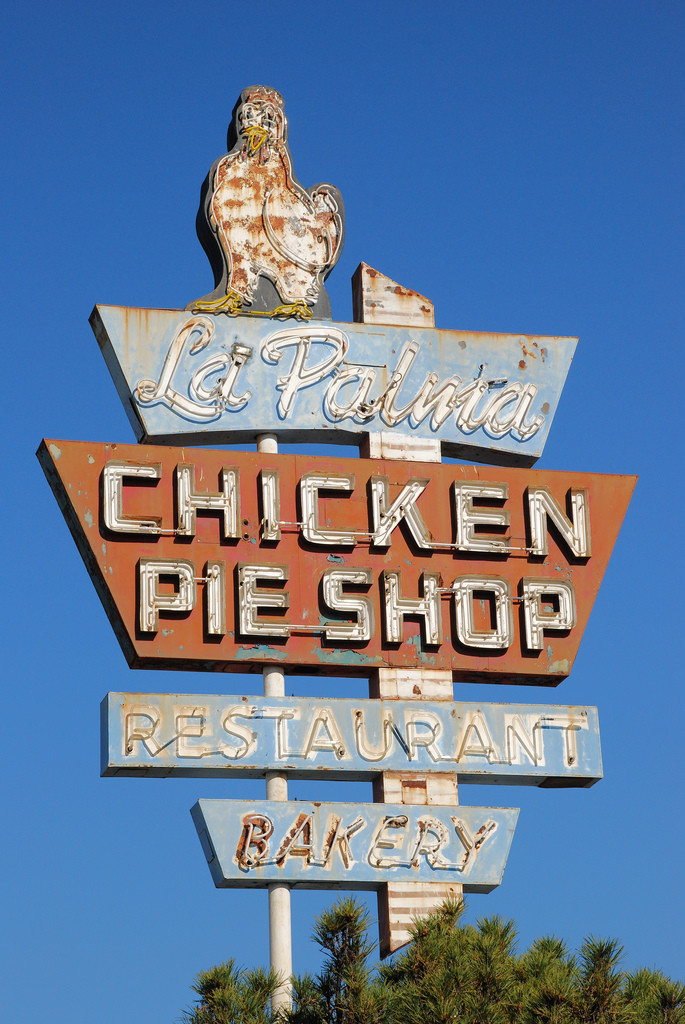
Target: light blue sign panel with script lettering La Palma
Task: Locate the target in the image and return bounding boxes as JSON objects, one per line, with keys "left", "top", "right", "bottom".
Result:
{"left": 91, "top": 306, "right": 575, "bottom": 466}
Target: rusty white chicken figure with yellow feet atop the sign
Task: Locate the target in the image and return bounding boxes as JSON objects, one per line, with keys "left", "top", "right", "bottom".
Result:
{"left": 187, "top": 85, "right": 345, "bottom": 319}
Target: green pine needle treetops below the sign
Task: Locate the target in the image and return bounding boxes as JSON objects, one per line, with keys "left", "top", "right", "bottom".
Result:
{"left": 183, "top": 897, "right": 685, "bottom": 1024}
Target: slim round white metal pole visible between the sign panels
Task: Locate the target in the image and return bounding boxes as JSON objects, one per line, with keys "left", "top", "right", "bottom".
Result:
{"left": 257, "top": 434, "right": 293, "bottom": 1011}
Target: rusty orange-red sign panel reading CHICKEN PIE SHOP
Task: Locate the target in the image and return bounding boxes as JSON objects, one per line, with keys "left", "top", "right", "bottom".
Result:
{"left": 38, "top": 441, "right": 636, "bottom": 685}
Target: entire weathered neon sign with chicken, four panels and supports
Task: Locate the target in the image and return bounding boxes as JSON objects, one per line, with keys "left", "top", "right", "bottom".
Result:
{"left": 39, "top": 86, "right": 635, "bottom": 974}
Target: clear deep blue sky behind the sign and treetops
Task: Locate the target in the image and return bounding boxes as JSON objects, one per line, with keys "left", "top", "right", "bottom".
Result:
{"left": 0, "top": 0, "right": 685, "bottom": 1024}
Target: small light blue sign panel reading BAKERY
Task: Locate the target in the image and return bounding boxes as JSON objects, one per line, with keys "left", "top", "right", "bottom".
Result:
{"left": 190, "top": 800, "right": 518, "bottom": 892}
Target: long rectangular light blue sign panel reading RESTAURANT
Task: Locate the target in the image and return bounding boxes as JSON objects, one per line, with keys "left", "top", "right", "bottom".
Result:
{"left": 101, "top": 693, "right": 602, "bottom": 787}
